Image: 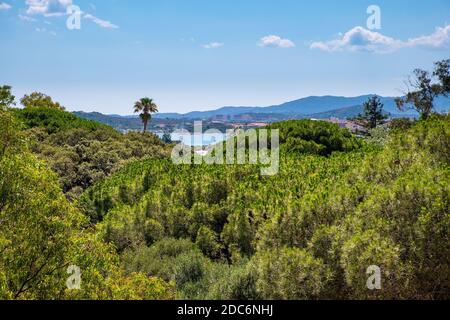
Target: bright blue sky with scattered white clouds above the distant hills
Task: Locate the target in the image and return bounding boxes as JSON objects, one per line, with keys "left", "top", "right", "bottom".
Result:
{"left": 0, "top": 0, "right": 450, "bottom": 115}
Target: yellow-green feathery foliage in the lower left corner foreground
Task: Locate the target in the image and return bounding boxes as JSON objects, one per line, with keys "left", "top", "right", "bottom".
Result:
{"left": 0, "top": 110, "right": 175, "bottom": 300}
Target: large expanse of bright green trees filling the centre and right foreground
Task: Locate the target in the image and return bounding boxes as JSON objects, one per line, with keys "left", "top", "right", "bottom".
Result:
{"left": 78, "top": 116, "right": 450, "bottom": 299}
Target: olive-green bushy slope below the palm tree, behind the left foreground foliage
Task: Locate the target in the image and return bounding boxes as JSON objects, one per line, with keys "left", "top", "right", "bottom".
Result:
{"left": 11, "top": 107, "right": 170, "bottom": 199}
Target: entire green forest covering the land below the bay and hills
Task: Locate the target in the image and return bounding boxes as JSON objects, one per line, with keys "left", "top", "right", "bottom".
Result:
{"left": 0, "top": 60, "right": 450, "bottom": 300}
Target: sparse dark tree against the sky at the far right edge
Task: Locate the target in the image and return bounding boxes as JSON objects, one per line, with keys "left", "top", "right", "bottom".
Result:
{"left": 396, "top": 59, "right": 450, "bottom": 120}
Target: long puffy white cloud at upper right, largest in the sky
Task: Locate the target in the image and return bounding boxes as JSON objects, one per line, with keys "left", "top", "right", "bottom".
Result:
{"left": 310, "top": 25, "right": 450, "bottom": 53}
